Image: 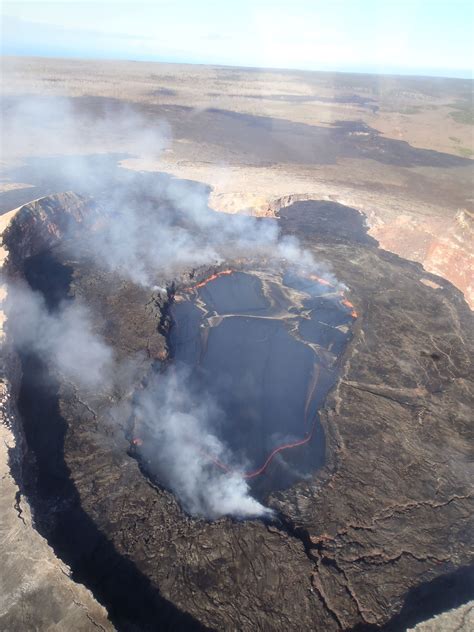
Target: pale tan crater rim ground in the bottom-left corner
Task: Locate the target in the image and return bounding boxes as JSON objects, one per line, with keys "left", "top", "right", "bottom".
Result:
{"left": 0, "top": 374, "right": 114, "bottom": 632}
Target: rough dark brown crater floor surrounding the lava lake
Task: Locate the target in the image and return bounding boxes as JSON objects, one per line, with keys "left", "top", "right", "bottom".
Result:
{"left": 1, "top": 197, "right": 473, "bottom": 631}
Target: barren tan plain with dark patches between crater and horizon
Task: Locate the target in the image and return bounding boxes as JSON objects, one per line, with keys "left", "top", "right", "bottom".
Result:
{"left": 0, "top": 58, "right": 474, "bottom": 307}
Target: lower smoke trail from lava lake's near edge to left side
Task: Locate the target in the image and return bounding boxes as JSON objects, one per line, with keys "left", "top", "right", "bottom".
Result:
{"left": 1, "top": 282, "right": 272, "bottom": 519}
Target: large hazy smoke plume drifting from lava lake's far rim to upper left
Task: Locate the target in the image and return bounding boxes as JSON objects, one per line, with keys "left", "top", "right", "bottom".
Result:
{"left": 2, "top": 96, "right": 340, "bottom": 287}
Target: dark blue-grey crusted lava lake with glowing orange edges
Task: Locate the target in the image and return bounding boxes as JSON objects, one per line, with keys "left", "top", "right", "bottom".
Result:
{"left": 135, "top": 269, "right": 357, "bottom": 498}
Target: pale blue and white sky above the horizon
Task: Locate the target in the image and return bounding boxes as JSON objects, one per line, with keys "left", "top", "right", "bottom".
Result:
{"left": 1, "top": 0, "right": 474, "bottom": 77}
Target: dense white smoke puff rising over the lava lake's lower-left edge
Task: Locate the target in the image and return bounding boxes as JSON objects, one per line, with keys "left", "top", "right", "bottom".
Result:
{"left": 136, "top": 368, "right": 272, "bottom": 519}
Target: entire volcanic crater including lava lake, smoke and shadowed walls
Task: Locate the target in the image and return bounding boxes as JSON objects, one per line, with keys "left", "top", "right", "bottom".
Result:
{"left": 1, "top": 186, "right": 474, "bottom": 632}
